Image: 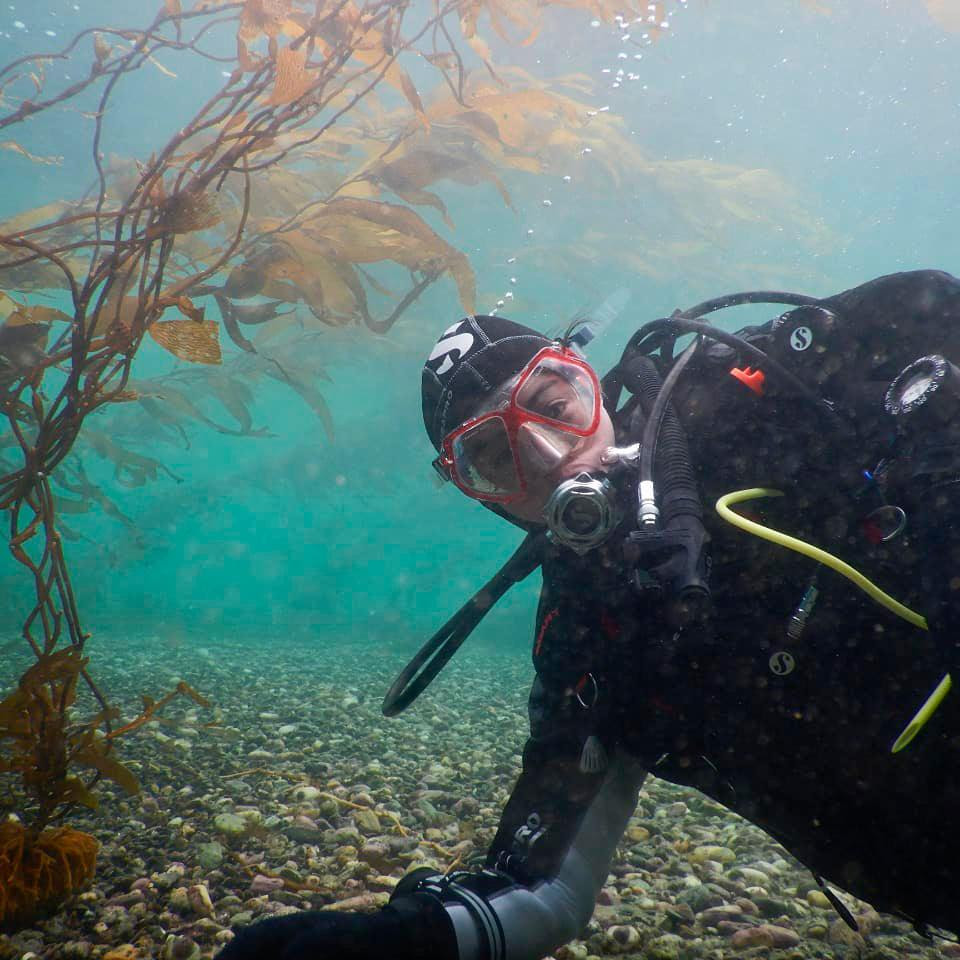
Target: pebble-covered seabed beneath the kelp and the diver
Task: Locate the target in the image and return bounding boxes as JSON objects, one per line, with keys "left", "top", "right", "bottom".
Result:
{"left": 0, "top": 638, "right": 960, "bottom": 960}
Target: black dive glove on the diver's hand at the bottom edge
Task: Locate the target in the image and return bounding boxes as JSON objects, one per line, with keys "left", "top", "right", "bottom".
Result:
{"left": 216, "top": 894, "right": 458, "bottom": 960}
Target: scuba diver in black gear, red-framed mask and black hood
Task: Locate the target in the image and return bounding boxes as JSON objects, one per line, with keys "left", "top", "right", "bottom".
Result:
{"left": 220, "top": 271, "right": 960, "bottom": 960}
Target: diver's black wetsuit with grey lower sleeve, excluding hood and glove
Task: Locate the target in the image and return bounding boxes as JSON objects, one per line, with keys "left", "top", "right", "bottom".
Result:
{"left": 394, "top": 271, "right": 960, "bottom": 960}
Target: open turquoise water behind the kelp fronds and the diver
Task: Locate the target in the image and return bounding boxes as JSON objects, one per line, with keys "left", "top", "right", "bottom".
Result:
{"left": 0, "top": 0, "right": 960, "bottom": 654}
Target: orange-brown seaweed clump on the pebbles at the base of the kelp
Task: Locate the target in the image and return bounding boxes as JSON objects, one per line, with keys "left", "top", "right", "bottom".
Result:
{"left": 0, "top": 821, "right": 98, "bottom": 930}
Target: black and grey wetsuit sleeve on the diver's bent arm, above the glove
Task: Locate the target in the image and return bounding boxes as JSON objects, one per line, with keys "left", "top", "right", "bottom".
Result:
{"left": 392, "top": 590, "right": 646, "bottom": 960}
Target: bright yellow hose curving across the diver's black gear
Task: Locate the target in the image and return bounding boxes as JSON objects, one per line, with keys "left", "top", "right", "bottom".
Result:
{"left": 717, "top": 487, "right": 952, "bottom": 753}
